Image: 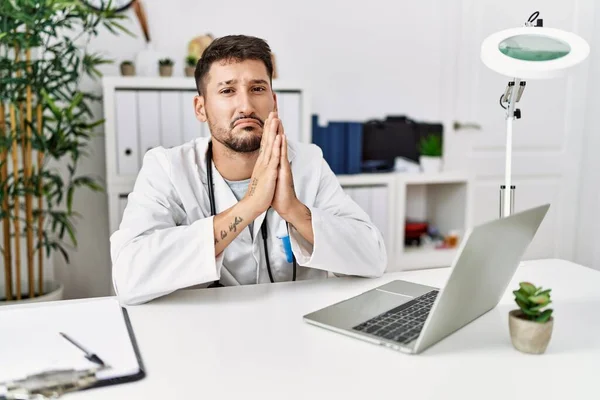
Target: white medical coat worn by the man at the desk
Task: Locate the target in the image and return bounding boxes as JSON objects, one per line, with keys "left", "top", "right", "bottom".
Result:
{"left": 110, "top": 138, "right": 387, "bottom": 304}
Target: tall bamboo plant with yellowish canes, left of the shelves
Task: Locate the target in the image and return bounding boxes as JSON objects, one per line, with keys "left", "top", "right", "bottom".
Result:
{"left": 0, "top": 0, "right": 125, "bottom": 304}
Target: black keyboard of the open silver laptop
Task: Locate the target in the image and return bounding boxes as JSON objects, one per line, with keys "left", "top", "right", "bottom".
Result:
{"left": 352, "top": 290, "right": 439, "bottom": 344}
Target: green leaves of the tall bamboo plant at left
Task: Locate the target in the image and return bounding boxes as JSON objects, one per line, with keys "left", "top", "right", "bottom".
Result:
{"left": 0, "top": 0, "right": 128, "bottom": 262}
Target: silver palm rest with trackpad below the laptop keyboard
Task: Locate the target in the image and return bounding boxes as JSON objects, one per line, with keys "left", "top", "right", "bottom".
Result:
{"left": 306, "top": 290, "right": 413, "bottom": 329}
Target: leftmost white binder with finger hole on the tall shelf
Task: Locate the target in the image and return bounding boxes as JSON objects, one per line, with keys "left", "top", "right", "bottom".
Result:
{"left": 115, "top": 90, "right": 140, "bottom": 175}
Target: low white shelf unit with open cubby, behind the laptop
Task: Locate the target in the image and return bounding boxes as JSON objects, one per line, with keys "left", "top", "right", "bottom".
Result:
{"left": 338, "top": 172, "right": 471, "bottom": 271}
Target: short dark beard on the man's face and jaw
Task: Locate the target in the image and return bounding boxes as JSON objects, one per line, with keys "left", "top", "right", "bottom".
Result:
{"left": 207, "top": 114, "right": 264, "bottom": 153}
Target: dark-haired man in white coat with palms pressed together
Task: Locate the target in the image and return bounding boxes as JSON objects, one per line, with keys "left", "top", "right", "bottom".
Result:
{"left": 111, "top": 36, "right": 387, "bottom": 304}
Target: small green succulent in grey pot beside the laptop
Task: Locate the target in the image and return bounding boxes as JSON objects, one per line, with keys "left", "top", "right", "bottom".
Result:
{"left": 509, "top": 282, "right": 554, "bottom": 354}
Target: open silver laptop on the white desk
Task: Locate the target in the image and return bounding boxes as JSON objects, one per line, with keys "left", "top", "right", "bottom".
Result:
{"left": 304, "top": 204, "right": 550, "bottom": 354}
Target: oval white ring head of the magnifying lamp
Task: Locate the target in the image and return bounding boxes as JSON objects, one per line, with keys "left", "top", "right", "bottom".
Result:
{"left": 481, "top": 26, "right": 590, "bottom": 79}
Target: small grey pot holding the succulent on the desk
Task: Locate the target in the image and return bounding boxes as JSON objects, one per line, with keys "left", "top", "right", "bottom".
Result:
{"left": 508, "top": 310, "right": 554, "bottom": 354}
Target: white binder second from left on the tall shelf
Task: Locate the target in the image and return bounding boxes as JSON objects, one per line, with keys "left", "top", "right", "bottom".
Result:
{"left": 137, "top": 90, "right": 160, "bottom": 158}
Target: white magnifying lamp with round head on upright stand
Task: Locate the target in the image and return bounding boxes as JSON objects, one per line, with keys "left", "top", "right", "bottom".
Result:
{"left": 481, "top": 11, "right": 590, "bottom": 217}
